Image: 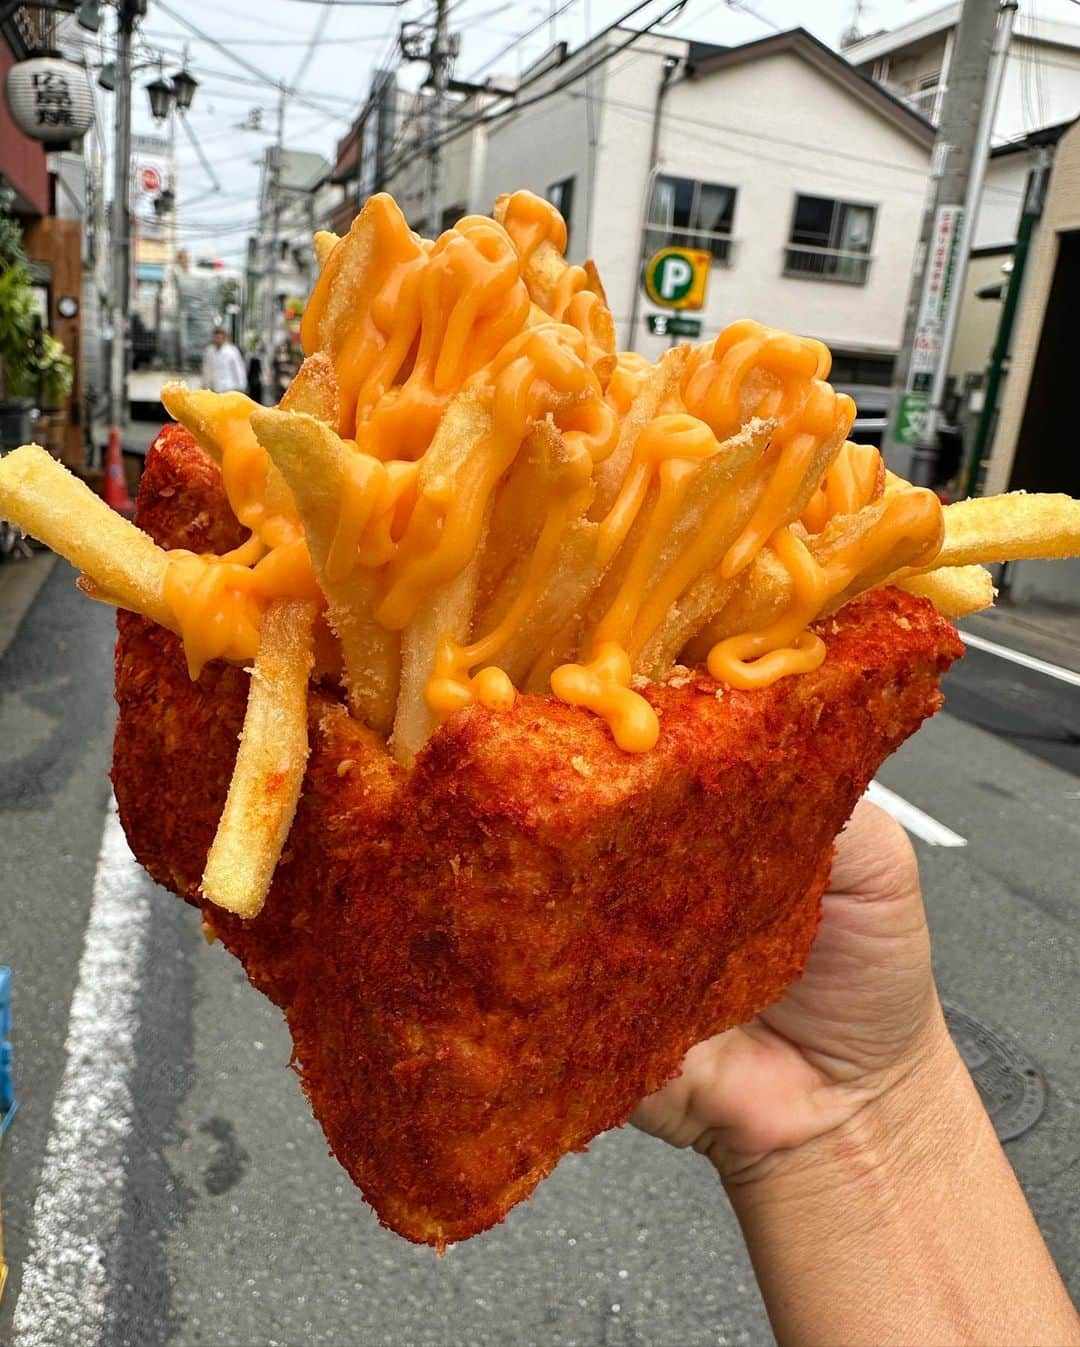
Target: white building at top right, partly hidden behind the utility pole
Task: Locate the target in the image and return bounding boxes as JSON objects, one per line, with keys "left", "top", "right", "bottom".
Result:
{"left": 844, "top": 4, "right": 1080, "bottom": 144}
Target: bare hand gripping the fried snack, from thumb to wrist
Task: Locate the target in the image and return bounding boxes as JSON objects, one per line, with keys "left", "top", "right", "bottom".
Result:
{"left": 632, "top": 800, "right": 951, "bottom": 1183}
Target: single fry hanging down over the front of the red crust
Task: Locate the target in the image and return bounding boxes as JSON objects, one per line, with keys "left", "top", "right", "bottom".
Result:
{"left": 202, "top": 599, "right": 316, "bottom": 917}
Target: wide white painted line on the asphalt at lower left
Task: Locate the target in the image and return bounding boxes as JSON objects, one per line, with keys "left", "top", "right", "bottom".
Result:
{"left": 15, "top": 804, "right": 149, "bottom": 1347}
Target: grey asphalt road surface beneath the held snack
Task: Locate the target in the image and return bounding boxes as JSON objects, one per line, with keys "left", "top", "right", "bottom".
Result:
{"left": 0, "top": 564, "right": 1080, "bottom": 1347}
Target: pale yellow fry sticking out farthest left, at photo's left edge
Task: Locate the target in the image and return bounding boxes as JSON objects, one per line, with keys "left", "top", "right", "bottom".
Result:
{"left": 0, "top": 445, "right": 176, "bottom": 632}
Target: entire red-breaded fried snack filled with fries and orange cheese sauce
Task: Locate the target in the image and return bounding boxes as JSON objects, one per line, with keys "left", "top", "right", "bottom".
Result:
{"left": 0, "top": 184, "right": 1080, "bottom": 1246}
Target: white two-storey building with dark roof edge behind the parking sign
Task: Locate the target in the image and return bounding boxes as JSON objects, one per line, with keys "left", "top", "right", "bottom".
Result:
{"left": 481, "top": 28, "right": 933, "bottom": 384}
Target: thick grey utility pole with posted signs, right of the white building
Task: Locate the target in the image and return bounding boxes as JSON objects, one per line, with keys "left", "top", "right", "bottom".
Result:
{"left": 883, "top": 0, "right": 1017, "bottom": 484}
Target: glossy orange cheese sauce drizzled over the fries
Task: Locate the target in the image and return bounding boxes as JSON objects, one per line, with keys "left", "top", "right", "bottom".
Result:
{"left": 155, "top": 194, "right": 940, "bottom": 752}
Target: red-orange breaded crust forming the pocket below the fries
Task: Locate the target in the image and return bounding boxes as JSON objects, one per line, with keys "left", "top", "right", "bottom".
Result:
{"left": 113, "top": 425, "right": 961, "bottom": 1246}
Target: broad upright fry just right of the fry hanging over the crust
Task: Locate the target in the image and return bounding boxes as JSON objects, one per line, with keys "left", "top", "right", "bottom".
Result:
{"left": 252, "top": 408, "right": 399, "bottom": 733}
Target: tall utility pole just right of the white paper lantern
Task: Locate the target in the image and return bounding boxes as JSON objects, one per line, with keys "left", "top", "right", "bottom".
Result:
{"left": 109, "top": 0, "right": 145, "bottom": 430}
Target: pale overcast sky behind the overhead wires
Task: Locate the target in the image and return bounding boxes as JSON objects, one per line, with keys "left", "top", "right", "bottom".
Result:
{"left": 86, "top": 0, "right": 1080, "bottom": 267}
